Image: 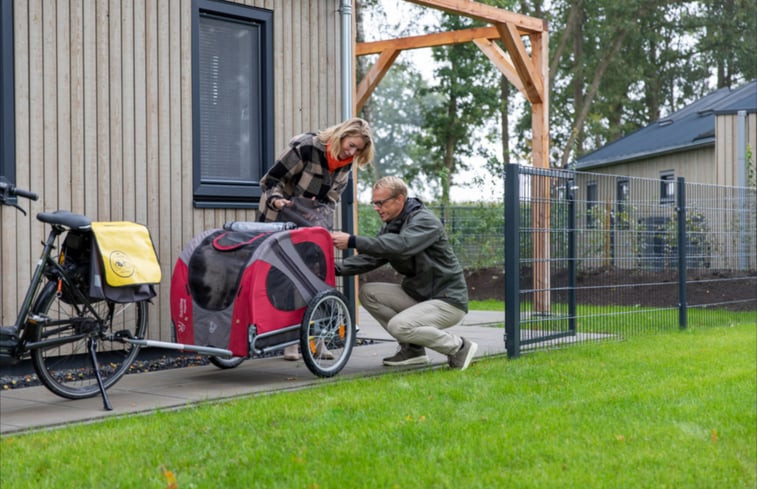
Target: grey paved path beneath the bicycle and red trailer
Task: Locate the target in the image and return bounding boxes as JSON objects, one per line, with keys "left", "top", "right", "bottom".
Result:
{"left": 0, "top": 310, "right": 505, "bottom": 434}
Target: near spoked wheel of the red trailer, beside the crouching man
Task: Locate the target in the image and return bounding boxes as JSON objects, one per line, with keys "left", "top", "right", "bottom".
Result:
{"left": 300, "top": 289, "right": 355, "bottom": 377}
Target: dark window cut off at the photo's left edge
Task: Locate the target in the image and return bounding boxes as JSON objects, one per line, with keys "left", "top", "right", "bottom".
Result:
{"left": 0, "top": 0, "right": 16, "bottom": 183}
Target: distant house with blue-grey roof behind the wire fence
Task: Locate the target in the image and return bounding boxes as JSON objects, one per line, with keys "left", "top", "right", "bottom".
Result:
{"left": 573, "top": 80, "right": 757, "bottom": 269}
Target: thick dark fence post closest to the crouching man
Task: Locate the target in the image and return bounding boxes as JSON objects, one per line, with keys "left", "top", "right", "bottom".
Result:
{"left": 505, "top": 163, "right": 520, "bottom": 358}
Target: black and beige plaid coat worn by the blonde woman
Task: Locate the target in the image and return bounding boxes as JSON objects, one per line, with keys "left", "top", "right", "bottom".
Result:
{"left": 258, "top": 132, "right": 352, "bottom": 222}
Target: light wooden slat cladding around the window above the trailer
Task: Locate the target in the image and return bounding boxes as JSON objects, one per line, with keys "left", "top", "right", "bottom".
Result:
{"left": 0, "top": 0, "right": 341, "bottom": 340}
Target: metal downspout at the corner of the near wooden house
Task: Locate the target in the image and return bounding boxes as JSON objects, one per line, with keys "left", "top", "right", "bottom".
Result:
{"left": 339, "top": 0, "right": 357, "bottom": 318}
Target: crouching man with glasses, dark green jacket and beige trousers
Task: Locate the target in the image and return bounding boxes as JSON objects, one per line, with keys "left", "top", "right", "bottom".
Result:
{"left": 331, "top": 176, "right": 478, "bottom": 370}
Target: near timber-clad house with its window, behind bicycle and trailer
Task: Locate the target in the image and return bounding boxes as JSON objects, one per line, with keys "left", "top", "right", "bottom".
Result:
{"left": 0, "top": 0, "right": 352, "bottom": 340}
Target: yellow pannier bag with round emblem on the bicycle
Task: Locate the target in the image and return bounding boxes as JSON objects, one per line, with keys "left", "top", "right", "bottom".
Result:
{"left": 92, "top": 221, "right": 161, "bottom": 287}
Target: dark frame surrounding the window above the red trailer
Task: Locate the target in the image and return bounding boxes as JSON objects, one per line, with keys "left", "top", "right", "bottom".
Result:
{"left": 192, "top": 0, "right": 274, "bottom": 209}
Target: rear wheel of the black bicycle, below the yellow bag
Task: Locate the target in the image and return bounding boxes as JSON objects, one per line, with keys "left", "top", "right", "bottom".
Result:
{"left": 31, "top": 281, "right": 147, "bottom": 399}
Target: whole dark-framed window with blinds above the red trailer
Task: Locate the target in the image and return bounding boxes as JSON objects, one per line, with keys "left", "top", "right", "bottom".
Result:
{"left": 192, "top": 0, "right": 274, "bottom": 208}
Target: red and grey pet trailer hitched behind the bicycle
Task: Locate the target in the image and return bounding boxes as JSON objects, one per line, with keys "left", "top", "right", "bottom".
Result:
{"left": 168, "top": 222, "right": 355, "bottom": 377}
